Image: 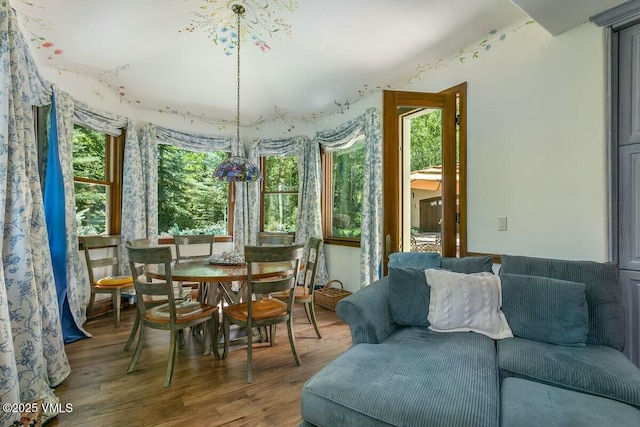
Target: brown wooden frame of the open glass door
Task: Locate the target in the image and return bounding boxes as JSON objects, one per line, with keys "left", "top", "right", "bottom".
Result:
{"left": 383, "top": 83, "right": 467, "bottom": 273}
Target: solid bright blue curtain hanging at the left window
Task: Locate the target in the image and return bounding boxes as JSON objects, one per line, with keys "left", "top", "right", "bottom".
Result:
{"left": 44, "top": 96, "right": 86, "bottom": 344}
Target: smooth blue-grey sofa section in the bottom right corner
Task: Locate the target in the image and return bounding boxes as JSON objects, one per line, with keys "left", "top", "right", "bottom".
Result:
{"left": 500, "top": 378, "right": 640, "bottom": 427}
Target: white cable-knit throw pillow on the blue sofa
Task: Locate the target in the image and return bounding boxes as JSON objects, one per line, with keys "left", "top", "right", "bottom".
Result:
{"left": 425, "top": 269, "right": 513, "bottom": 339}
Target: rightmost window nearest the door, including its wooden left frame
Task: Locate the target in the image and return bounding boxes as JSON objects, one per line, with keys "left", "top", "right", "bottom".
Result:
{"left": 323, "top": 138, "right": 365, "bottom": 243}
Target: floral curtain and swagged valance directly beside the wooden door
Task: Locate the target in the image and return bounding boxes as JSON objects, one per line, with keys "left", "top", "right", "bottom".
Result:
{"left": 315, "top": 108, "right": 382, "bottom": 286}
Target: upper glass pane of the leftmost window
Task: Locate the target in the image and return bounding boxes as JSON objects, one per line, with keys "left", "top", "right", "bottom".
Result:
{"left": 73, "top": 125, "right": 107, "bottom": 181}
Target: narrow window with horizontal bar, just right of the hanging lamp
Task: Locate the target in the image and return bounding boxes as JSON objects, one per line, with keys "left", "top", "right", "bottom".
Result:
{"left": 262, "top": 156, "right": 299, "bottom": 232}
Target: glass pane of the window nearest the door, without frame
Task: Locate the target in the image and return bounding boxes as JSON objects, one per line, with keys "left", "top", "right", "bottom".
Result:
{"left": 331, "top": 141, "right": 364, "bottom": 237}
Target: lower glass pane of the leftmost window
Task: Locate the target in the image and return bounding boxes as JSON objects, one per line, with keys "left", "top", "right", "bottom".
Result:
{"left": 74, "top": 182, "right": 108, "bottom": 236}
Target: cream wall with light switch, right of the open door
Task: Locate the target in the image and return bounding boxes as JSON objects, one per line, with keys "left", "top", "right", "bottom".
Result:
{"left": 325, "top": 23, "right": 608, "bottom": 288}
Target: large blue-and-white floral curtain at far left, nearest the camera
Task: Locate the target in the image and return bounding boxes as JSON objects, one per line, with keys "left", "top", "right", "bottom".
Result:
{"left": 0, "top": 4, "right": 71, "bottom": 425}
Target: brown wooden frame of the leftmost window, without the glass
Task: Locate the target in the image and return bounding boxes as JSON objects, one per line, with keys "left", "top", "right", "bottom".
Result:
{"left": 73, "top": 122, "right": 126, "bottom": 236}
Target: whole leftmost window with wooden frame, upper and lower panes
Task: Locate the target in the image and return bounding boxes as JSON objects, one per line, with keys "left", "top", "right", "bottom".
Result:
{"left": 73, "top": 125, "right": 124, "bottom": 236}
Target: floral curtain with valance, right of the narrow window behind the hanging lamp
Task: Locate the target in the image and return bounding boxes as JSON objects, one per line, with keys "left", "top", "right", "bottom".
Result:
{"left": 250, "top": 136, "right": 329, "bottom": 285}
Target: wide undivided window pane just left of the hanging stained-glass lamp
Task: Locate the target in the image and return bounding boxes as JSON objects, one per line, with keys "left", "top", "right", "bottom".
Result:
{"left": 158, "top": 145, "right": 229, "bottom": 234}
